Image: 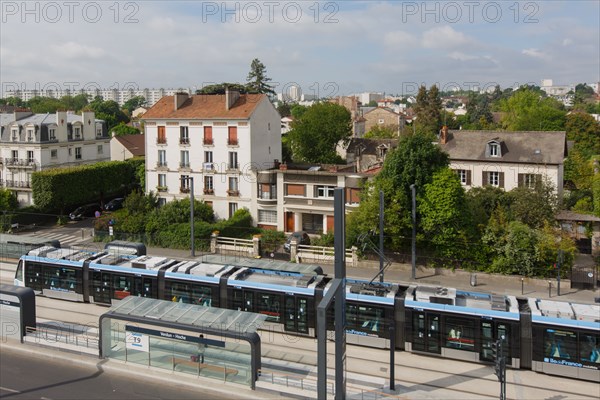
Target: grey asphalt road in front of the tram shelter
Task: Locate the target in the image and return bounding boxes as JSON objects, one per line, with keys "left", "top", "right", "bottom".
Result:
{"left": 0, "top": 345, "right": 231, "bottom": 400}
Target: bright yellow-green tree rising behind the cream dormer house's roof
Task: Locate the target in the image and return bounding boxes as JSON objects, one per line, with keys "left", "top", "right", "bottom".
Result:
{"left": 499, "top": 88, "right": 566, "bottom": 131}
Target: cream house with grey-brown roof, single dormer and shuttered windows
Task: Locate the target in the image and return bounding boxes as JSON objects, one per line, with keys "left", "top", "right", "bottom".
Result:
{"left": 439, "top": 128, "right": 567, "bottom": 196}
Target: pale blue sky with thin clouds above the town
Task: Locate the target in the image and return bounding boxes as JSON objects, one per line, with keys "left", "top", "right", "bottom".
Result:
{"left": 0, "top": 0, "right": 600, "bottom": 97}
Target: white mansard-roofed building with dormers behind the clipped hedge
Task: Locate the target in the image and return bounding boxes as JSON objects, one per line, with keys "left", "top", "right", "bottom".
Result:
{"left": 0, "top": 109, "right": 110, "bottom": 207}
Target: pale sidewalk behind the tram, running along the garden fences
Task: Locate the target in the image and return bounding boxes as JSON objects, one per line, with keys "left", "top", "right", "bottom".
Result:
{"left": 148, "top": 247, "right": 600, "bottom": 303}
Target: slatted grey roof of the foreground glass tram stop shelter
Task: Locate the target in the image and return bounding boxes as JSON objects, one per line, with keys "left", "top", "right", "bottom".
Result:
{"left": 105, "top": 296, "right": 267, "bottom": 333}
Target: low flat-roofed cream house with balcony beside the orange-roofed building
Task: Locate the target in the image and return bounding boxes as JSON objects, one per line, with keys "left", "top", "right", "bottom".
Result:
{"left": 256, "top": 164, "right": 369, "bottom": 233}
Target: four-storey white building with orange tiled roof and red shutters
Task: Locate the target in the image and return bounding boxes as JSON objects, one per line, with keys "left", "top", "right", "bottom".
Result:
{"left": 142, "top": 90, "right": 281, "bottom": 219}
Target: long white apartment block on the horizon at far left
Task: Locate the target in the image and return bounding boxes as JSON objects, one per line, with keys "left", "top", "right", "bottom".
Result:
{"left": 4, "top": 88, "right": 194, "bottom": 107}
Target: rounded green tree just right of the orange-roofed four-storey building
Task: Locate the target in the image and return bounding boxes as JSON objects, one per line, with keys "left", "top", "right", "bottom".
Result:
{"left": 287, "top": 102, "right": 352, "bottom": 164}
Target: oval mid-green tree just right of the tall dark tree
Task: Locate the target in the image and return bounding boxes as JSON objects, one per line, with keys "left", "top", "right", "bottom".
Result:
{"left": 418, "top": 168, "right": 475, "bottom": 267}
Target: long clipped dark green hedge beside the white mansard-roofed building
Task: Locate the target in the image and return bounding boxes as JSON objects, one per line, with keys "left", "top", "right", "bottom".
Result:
{"left": 31, "top": 161, "right": 137, "bottom": 214}
